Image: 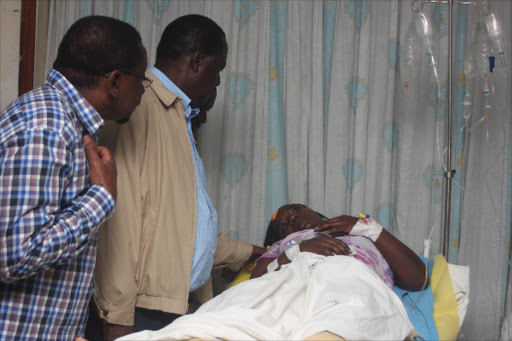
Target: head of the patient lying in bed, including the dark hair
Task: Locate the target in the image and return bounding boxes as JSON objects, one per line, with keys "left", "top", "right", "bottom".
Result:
{"left": 264, "top": 204, "right": 327, "bottom": 246}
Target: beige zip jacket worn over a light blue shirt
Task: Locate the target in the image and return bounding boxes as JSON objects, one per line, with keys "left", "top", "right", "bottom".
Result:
{"left": 94, "top": 71, "right": 252, "bottom": 325}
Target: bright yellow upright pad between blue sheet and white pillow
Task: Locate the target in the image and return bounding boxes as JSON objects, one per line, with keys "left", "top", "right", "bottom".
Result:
{"left": 430, "top": 254, "right": 460, "bottom": 340}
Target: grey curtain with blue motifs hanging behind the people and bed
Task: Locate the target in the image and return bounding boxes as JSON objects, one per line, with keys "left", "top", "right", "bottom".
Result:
{"left": 46, "top": 0, "right": 512, "bottom": 340}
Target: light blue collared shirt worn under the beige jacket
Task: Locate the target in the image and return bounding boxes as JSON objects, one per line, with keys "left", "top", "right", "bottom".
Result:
{"left": 149, "top": 67, "right": 217, "bottom": 292}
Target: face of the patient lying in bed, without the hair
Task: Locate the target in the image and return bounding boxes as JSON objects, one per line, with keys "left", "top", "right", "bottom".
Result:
{"left": 276, "top": 204, "right": 323, "bottom": 239}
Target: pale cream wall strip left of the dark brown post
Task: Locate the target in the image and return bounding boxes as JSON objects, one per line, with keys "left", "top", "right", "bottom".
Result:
{"left": 0, "top": 0, "right": 21, "bottom": 111}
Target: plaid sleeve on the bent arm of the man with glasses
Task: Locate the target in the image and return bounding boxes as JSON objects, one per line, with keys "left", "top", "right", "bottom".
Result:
{"left": 0, "top": 130, "right": 114, "bottom": 283}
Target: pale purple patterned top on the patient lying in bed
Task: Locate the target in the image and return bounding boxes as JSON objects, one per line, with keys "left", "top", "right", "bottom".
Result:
{"left": 256, "top": 229, "right": 393, "bottom": 289}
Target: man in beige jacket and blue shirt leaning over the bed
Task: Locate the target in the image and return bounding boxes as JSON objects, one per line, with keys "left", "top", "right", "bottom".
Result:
{"left": 91, "top": 15, "right": 265, "bottom": 340}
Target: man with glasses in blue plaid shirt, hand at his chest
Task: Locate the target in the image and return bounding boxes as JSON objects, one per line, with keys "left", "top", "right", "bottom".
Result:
{"left": 0, "top": 16, "right": 151, "bottom": 340}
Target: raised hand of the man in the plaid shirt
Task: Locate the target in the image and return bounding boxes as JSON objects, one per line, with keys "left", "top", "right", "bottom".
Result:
{"left": 83, "top": 135, "right": 117, "bottom": 200}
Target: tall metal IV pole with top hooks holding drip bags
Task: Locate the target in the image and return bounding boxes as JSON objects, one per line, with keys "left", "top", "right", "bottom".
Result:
{"left": 411, "top": 0, "right": 490, "bottom": 260}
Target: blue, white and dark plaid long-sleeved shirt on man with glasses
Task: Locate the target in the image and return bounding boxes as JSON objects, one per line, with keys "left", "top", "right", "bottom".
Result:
{"left": 0, "top": 70, "right": 114, "bottom": 340}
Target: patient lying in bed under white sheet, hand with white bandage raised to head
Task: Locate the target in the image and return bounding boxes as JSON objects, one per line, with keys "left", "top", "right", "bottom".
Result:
{"left": 121, "top": 205, "right": 428, "bottom": 340}
